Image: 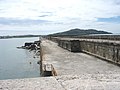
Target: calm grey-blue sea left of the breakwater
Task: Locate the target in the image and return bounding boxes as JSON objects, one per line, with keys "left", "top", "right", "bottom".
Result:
{"left": 0, "top": 38, "right": 40, "bottom": 80}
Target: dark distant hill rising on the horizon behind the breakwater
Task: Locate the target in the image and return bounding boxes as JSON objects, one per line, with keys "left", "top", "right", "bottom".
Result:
{"left": 48, "top": 28, "right": 112, "bottom": 36}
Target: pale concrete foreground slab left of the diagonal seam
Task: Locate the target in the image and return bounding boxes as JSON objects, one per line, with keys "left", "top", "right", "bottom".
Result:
{"left": 0, "top": 77, "right": 64, "bottom": 90}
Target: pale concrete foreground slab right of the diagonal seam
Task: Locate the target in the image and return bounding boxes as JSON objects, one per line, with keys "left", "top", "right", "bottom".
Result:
{"left": 56, "top": 74, "right": 120, "bottom": 90}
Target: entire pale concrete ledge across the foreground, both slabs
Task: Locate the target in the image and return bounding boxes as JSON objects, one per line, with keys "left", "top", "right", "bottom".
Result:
{"left": 0, "top": 74, "right": 120, "bottom": 90}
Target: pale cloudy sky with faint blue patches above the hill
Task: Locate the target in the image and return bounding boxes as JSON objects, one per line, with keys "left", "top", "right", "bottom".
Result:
{"left": 0, "top": 0, "right": 120, "bottom": 36}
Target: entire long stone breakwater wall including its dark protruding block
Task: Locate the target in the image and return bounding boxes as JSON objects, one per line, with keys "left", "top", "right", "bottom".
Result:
{"left": 47, "top": 37, "right": 120, "bottom": 64}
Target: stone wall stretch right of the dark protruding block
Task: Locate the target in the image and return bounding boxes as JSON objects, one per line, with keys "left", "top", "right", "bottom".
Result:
{"left": 80, "top": 41, "right": 120, "bottom": 64}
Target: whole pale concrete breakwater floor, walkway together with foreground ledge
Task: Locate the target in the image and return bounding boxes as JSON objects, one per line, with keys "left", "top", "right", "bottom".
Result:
{"left": 0, "top": 39, "right": 120, "bottom": 90}
